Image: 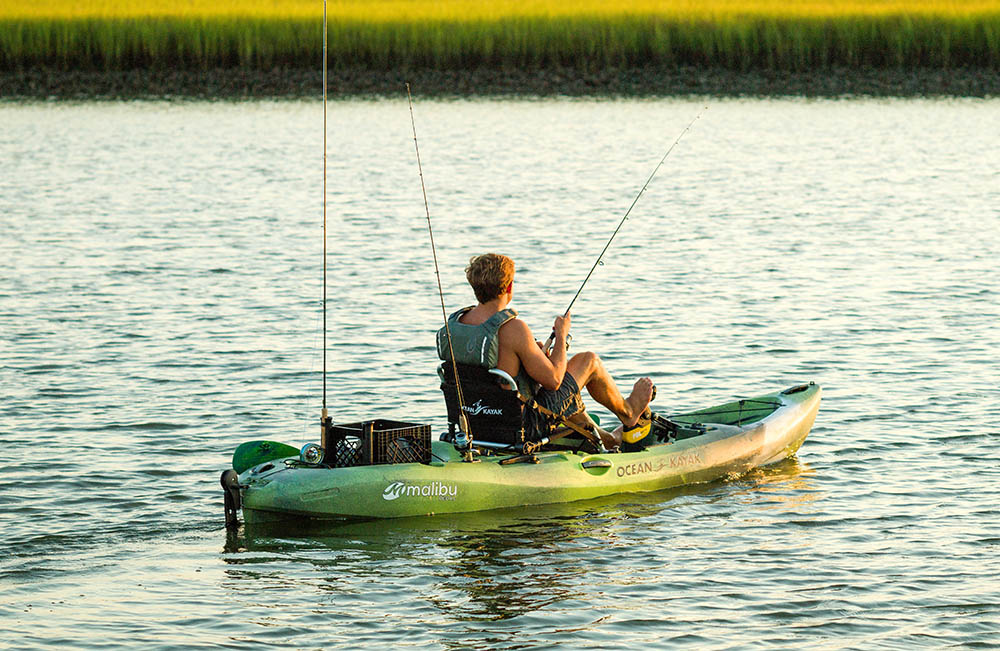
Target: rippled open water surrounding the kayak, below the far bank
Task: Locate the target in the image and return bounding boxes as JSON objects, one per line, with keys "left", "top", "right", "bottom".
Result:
{"left": 0, "top": 99, "right": 1000, "bottom": 649}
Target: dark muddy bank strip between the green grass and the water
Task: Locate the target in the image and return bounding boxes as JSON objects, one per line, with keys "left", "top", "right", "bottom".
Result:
{"left": 0, "top": 66, "right": 1000, "bottom": 101}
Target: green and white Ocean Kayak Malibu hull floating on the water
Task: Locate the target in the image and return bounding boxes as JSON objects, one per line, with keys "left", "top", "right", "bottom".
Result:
{"left": 223, "top": 383, "right": 821, "bottom": 525}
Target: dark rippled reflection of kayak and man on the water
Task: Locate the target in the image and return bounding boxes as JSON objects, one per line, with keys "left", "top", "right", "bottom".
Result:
{"left": 223, "top": 459, "right": 818, "bottom": 622}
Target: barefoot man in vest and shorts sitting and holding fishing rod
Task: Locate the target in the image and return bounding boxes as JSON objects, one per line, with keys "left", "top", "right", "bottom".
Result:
{"left": 437, "top": 253, "right": 654, "bottom": 448}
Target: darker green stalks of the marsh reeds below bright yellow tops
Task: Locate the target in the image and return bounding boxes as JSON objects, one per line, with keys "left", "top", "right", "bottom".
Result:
{"left": 0, "top": 13, "right": 1000, "bottom": 70}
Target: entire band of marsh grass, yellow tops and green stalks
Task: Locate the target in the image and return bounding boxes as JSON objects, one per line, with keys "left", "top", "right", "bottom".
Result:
{"left": 0, "top": 0, "right": 1000, "bottom": 70}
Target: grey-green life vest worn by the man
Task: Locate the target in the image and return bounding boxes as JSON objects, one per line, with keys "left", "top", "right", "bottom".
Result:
{"left": 437, "top": 306, "right": 535, "bottom": 399}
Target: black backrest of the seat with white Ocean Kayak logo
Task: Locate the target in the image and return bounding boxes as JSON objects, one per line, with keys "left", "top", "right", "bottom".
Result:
{"left": 438, "top": 362, "right": 525, "bottom": 445}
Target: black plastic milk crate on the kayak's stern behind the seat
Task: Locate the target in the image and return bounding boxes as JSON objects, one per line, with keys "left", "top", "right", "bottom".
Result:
{"left": 323, "top": 419, "right": 431, "bottom": 468}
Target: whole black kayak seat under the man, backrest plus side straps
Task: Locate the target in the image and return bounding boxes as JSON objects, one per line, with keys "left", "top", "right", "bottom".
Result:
{"left": 438, "top": 362, "right": 600, "bottom": 447}
